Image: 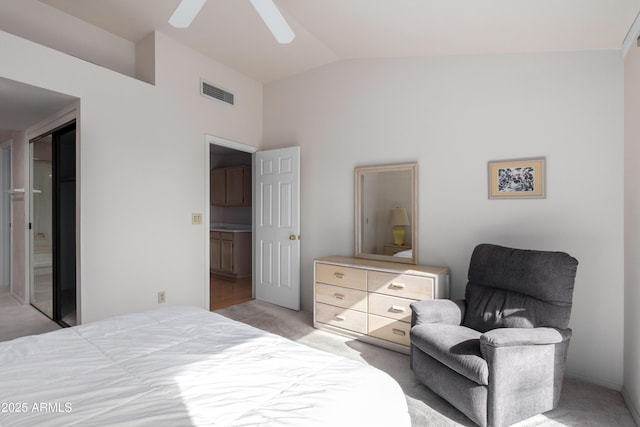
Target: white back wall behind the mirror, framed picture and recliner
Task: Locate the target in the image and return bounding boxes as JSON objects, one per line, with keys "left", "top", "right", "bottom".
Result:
{"left": 264, "top": 51, "right": 623, "bottom": 389}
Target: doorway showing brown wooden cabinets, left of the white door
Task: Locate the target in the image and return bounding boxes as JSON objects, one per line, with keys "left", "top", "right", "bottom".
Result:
{"left": 209, "top": 139, "right": 253, "bottom": 310}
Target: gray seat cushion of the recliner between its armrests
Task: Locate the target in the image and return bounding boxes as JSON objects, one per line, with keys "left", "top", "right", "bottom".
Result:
{"left": 411, "top": 323, "right": 489, "bottom": 385}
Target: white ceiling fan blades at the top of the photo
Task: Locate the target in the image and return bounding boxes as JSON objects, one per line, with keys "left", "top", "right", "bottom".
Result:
{"left": 169, "top": 0, "right": 296, "bottom": 44}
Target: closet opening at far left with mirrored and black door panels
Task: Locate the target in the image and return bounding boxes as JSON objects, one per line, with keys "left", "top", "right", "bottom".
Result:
{"left": 29, "top": 120, "right": 77, "bottom": 326}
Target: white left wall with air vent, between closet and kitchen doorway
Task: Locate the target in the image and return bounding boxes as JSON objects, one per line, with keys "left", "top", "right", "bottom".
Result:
{"left": 0, "top": 32, "right": 262, "bottom": 322}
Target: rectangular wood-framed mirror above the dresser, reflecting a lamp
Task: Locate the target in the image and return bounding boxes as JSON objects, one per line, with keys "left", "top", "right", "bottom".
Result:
{"left": 355, "top": 163, "right": 418, "bottom": 264}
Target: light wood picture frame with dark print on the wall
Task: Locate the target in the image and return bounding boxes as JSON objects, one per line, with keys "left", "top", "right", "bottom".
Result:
{"left": 488, "top": 157, "right": 546, "bottom": 199}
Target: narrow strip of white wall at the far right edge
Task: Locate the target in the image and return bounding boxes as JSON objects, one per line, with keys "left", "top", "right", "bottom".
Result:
{"left": 623, "top": 38, "right": 640, "bottom": 424}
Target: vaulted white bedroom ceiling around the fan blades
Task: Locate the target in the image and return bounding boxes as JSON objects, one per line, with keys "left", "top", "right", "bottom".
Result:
{"left": 40, "top": 0, "right": 640, "bottom": 82}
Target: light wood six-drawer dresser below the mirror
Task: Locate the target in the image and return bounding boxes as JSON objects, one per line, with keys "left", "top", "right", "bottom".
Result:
{"left": 313, "top": 256, "right": 449, "bottom": 354}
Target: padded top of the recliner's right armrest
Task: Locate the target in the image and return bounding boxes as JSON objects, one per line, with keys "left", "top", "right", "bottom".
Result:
{"left": 480, "top": 328, "right": 572, "bottom": 347}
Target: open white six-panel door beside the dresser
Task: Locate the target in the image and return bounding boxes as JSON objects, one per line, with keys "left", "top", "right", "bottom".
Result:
{"left": 253, "top": 147, "right": 300, "bottom": 310}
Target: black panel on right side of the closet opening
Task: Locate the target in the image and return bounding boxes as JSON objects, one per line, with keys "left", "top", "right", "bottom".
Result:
{"left": 52, "top": 122, "right": 77, "bottom": 326}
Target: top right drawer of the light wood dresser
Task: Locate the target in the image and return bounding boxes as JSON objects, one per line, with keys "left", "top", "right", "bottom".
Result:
{"left": 367, "top": 271, "right": 433, "bottom": 300}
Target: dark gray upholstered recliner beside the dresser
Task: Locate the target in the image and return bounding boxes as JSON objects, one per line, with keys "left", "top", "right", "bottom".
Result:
{"left": 411, "top": 244, "right": 578, "bottom": 427}
